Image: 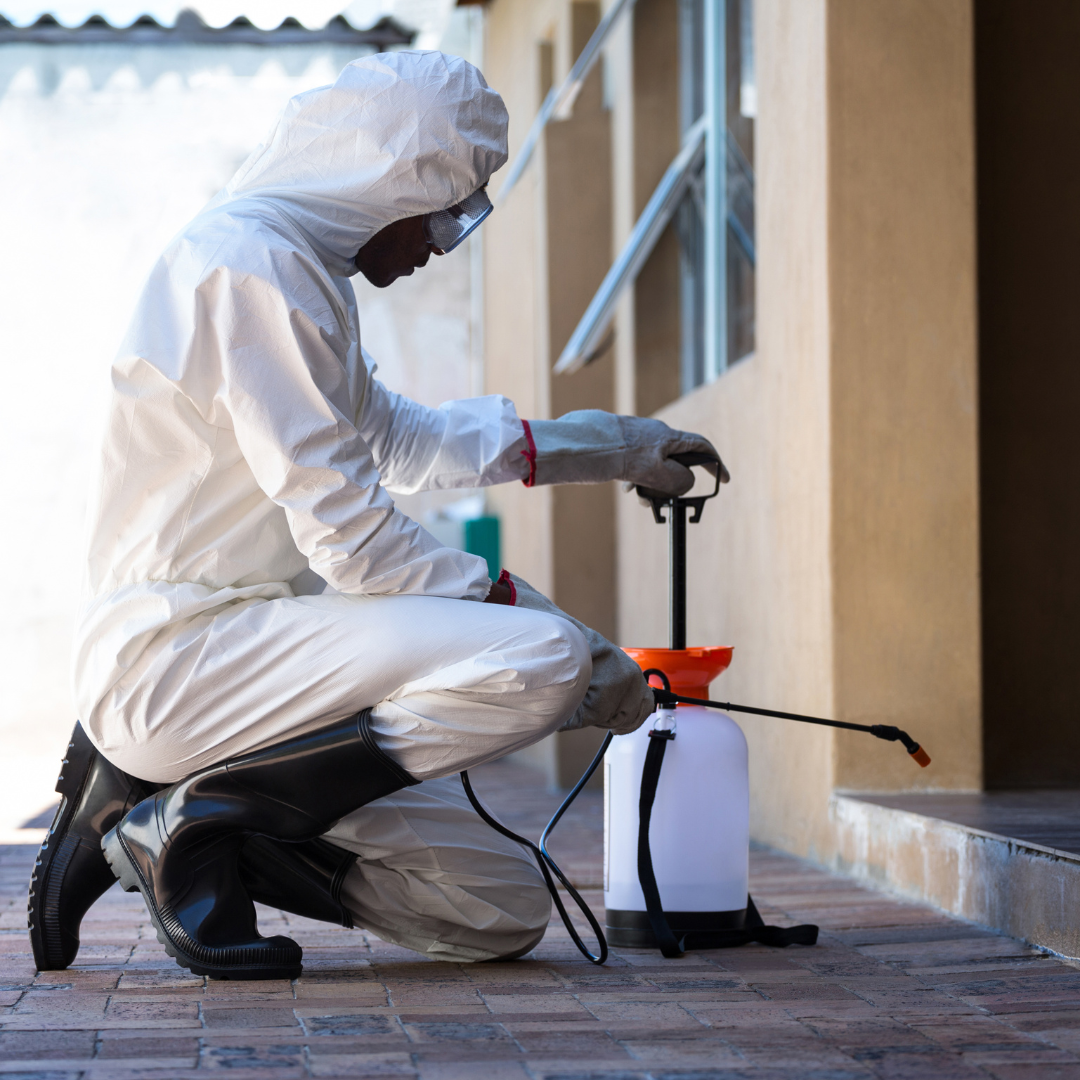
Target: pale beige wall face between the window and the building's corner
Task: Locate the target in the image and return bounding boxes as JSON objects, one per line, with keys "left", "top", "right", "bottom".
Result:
{"left": 620, "top": 0, "right": 834, "bottom": 851}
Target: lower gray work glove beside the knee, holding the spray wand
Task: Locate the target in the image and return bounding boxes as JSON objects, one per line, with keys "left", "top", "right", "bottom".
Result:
{"left": 510, "top": 573, "right": 657, "bottom": 735}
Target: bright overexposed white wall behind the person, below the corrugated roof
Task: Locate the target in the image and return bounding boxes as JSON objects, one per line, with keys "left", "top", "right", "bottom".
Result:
{"left": 0, "top": 35, "right": 473, "bottom": 841}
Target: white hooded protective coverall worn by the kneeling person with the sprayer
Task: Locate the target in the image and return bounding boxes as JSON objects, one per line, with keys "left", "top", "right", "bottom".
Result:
{"left": 73, "top": 52, "right": 591, "bottom": 959}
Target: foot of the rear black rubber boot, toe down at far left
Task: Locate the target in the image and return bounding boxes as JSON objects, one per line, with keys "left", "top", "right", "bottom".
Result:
{"left": 27, "top": 724, "right": 157, "bottom": 971}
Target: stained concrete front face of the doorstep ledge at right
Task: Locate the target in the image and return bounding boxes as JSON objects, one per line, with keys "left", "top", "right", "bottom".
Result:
{"left": 829, "top": 795, "right": 1080, "bottom": 958}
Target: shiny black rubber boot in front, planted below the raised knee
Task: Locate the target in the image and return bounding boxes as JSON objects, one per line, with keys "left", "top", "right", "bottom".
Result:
{"left": 102, "top": 711, "right": 416, "bottom": 978}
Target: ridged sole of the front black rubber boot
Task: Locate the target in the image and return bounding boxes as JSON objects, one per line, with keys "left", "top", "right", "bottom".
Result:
{"left": 102, "top": 828, "right": 302, "bottom": 980}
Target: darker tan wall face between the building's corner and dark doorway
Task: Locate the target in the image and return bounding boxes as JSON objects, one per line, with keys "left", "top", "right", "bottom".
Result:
{"left": 828, "top": 0, "right": 982, "bottom": 789}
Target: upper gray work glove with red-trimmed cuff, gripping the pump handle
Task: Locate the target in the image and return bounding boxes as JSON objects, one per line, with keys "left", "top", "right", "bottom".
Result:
{"left": 529, "top": 408, "right": 730, "bottom": 496}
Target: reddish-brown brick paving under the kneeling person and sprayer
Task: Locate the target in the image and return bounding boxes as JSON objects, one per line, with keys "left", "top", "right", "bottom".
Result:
{"left": 0, "top": 764, "right": 1080, "bottom": 1080}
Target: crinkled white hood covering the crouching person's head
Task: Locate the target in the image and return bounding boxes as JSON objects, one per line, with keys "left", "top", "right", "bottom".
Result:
{"left": 206, "top": 52, "right": 507, "bottom": 276}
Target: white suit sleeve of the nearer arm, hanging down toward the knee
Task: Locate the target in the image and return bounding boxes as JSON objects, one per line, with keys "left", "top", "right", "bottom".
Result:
{"left": 204, "top": 265, "right": 490, "bottom": 599}
